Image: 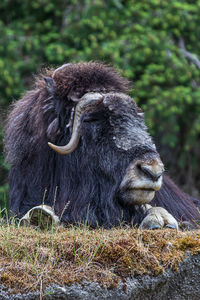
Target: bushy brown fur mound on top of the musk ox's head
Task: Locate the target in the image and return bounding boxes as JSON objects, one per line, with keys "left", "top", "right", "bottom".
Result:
{"left": 50, "top": 63, "right": 129, "bottom": 99}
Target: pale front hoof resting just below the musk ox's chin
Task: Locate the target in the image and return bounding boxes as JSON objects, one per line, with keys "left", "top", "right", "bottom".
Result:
{"left": 140, "top": 204, "right": 178, "bottom": 230}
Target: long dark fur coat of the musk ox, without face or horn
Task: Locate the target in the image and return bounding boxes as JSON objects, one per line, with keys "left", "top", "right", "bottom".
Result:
{"left": 5, "top": 63, "right": 200, "bottom": 227}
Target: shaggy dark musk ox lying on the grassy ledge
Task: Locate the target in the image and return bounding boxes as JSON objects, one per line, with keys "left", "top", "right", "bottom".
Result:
{"left": 5, "top": 62, "right": 200, "bottom": 228}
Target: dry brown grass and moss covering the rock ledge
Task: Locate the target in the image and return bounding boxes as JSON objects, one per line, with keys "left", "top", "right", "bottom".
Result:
{"left": 0, "top": 225, "right": 200, "bottom": 292}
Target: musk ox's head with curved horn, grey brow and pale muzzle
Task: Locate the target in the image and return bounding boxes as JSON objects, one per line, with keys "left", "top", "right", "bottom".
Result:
{"left": 45, "top": 63, "right": 164, "bottom": 209}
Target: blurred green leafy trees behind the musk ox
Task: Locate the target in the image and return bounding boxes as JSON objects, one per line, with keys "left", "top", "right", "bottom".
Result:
{"left": 0, "top": 0, "right": 200, "bottom": 207}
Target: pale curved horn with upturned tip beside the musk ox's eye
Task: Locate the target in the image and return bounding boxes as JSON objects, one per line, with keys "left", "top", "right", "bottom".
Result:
{"left": 48, "top": 93, "right": 104, "bottom": 154}
